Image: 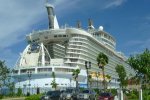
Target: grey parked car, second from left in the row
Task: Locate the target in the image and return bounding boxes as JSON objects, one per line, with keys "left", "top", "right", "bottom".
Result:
{"left": 60, "top": 88, "right": 78, "bottom": 100}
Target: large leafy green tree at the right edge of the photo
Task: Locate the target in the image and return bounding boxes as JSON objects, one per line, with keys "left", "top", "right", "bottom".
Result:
{"left": 128, "top": 49, "right": 150, "bottom": 88}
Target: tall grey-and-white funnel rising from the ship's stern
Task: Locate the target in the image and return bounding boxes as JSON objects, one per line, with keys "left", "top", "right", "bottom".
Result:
{"left": 46, "top": 3, "right": 59, "bottom": 29}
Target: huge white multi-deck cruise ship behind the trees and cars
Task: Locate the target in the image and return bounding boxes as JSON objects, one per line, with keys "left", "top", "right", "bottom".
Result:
{"left": 12, "top": 3, "right": 134, "bottom": 93}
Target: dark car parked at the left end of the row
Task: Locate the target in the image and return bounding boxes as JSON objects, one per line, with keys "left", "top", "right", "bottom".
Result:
{"left": 40, "top": 90, "right": 61, "bottom": 100}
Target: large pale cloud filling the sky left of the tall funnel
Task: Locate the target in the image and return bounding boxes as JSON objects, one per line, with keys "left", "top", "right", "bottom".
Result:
{"left": 0, "top": 0, "right": 44, "bottom": 49}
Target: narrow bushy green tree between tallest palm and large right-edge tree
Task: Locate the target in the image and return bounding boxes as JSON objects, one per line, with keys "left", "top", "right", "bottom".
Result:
{"left": 115, "top": 65, "right": 127, "bottom": 88}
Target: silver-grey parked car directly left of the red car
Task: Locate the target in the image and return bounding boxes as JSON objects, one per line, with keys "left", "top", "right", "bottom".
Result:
{"left": 77, "top": 89, "right": 97, "bottom": 100}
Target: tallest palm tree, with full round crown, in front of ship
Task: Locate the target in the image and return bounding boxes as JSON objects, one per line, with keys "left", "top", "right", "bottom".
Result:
{"left": 97, "top": 52, "right": 109, "bottom": 91}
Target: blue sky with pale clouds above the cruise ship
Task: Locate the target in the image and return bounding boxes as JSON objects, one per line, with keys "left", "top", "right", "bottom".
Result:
{"left": 0, "top": 0, "right": 150, "bottom": 67}
